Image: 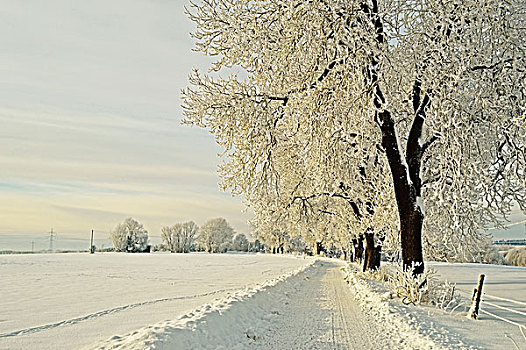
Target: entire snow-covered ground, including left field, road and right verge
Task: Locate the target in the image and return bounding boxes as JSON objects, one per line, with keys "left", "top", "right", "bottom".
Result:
{"left": 0, "top": 254, "right": 526, "bottom": 350}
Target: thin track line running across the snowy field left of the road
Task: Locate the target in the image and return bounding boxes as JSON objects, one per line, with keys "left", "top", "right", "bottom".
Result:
{"left": 0, "top": 288, "right": 239, "bottom": 338}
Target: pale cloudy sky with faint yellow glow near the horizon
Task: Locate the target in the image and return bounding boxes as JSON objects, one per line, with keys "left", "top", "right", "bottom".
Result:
{"left": 0, "top": 0, "right": 526, "bottom": 250}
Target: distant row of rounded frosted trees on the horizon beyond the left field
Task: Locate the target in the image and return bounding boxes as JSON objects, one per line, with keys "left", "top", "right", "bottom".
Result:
{"left": 110, "top": 218, "right": 248, "bottom": 253}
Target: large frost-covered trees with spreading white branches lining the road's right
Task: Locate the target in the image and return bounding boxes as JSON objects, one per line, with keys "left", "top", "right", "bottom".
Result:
{"left": 183, "top": 0, "right": 526, "bottom": 273}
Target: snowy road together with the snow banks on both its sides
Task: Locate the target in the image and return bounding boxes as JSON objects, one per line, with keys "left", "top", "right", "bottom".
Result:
{"left": 87, "top": 258, "right": 454, "bottom": 350}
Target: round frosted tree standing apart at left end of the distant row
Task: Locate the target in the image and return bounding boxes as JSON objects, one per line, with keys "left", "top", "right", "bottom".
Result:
{"left": 110, "top": 218, "right": 148, "bottom": 253}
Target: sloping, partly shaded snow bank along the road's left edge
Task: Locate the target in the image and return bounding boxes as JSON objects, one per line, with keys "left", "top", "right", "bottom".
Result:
{"left": 89, "top": 260, "right": 315, "bottom": 350}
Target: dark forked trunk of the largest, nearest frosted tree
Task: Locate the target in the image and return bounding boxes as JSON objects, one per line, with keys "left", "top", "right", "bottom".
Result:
{"left": 362, "top": 0, "right": 433, "bottom": 275}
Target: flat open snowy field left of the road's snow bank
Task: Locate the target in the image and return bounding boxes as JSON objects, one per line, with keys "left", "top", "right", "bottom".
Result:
{"left": 0, "top": 253, "right": 312, "bottom": 350}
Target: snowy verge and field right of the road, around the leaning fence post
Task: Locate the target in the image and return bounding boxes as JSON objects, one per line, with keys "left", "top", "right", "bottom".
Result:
{"left": 348, "top": 262, "right": 526, "bottom": 350}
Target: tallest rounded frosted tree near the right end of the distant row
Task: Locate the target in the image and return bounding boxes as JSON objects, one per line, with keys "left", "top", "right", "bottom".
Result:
{"left": 197, "top": 218, "right": 234, "bottom": 253}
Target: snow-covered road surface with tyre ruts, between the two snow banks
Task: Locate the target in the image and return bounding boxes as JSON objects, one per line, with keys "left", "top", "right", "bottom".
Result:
{"left": 245, "top": 261, "right": 387, "bottom": 349}
